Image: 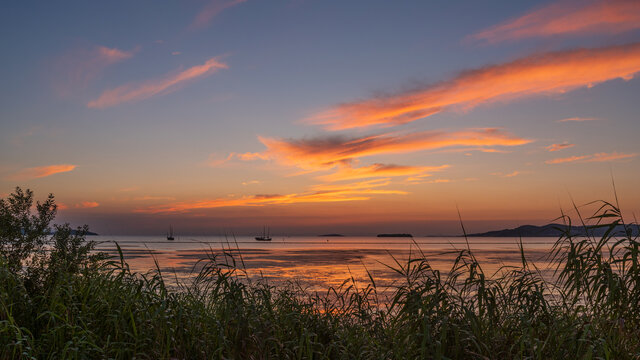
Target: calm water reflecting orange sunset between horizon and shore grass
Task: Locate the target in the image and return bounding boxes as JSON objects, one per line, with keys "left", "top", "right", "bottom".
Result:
{"left": 91, "top": 236, "right": 557, "bottom": 290}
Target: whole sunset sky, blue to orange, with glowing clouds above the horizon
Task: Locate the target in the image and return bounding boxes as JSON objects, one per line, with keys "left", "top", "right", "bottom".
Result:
{"left": 0, "top": 0, "right": 640, "bottom": 236}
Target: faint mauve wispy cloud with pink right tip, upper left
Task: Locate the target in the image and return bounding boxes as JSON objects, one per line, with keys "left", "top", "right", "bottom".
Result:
{"left": 52, "top": 46, "right": 137, "bottom": 96}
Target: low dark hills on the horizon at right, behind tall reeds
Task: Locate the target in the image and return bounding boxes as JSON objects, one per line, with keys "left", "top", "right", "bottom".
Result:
{"left": 467, "top": 224, "right": 640, "bottom": 237}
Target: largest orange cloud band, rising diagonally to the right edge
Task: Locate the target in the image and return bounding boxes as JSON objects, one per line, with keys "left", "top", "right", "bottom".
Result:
{"left": 307, "top": 43, "right": 640, "bottom": 130}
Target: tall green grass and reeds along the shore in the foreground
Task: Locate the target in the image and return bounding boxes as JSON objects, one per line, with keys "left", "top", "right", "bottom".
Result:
{"left": 0, "top": 190, "right": 640, "bottom": 359}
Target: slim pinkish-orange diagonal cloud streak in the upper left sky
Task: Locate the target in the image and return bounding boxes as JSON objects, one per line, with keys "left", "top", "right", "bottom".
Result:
{"left": 87, "top": 57, "right": 229, "bottom": 109}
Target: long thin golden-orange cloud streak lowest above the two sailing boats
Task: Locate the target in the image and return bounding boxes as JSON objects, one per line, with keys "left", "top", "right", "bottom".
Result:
{"left": 136, "top": 181, "right": 407, "bottom": 214}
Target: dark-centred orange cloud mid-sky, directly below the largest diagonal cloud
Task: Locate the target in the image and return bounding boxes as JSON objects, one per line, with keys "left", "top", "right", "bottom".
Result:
{"left": 239, "top": 129, "right": 531, "bottom": 171}
